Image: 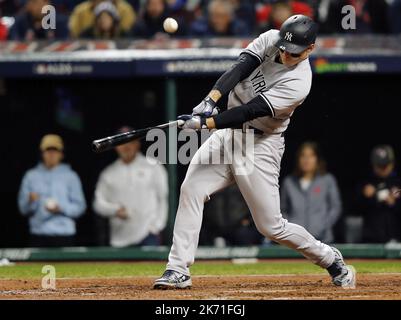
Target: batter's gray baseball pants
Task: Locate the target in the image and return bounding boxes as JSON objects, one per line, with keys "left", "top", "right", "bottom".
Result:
{"left": 167, "top": 129, "right": 334, "bottom": 275}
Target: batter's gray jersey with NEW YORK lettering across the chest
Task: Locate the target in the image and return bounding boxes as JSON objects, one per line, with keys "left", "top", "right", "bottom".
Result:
{"left": 228, "top": 30, "right": 312, "bottom": 134}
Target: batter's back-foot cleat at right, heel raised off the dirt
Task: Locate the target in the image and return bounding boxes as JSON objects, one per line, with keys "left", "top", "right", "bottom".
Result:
{"left": 328, "top": 247, "right": 356, "bottom": 289}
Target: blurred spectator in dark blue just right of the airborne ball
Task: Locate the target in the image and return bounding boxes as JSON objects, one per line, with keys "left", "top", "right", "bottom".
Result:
{"left": 190, "top": 0, "right": 250, "bottom": 37}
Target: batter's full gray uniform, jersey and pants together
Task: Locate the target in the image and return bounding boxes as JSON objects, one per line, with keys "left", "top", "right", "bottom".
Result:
{"left": 167, "top": 30, "right": 334, "bottom": 275}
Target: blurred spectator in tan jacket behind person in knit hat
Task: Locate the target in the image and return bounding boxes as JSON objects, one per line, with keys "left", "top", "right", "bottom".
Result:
{"left": 69, "top": 0, "right": 136, "bottom": 37}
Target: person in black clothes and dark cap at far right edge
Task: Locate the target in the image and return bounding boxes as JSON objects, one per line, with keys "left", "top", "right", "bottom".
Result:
{"left": 359, "top": 145, "right": 401, "bottom": 243}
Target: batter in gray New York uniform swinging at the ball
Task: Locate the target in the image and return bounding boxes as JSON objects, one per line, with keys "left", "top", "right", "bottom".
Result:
{"left": 153, "top": 15, "right": 356, "bottom": 289}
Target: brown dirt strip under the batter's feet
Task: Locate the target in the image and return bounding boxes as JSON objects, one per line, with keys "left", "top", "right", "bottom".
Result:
{"left": 0, "top": 274, "right": 401, "bottom": 300}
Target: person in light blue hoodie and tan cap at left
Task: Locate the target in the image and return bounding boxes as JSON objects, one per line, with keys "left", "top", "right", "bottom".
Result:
{"left": 18, "top": 134, "right": 86, "bottom": 247}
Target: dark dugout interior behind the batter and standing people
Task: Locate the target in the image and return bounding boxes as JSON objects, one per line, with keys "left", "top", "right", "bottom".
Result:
{"left": 0, "top": 75, "right": 401, "bottom": 247}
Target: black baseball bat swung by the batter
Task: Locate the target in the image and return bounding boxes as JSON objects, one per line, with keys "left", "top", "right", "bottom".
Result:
{"left": 92, "top": 120, "right": 184, "bottom": 153}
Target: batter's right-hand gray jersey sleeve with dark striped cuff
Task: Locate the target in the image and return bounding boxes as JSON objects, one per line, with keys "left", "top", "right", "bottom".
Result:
{"left": 260, "top": 80, "right": 310, "bottom": 119}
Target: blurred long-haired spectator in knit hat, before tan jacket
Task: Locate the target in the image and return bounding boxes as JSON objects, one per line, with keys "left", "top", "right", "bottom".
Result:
{"left": 79, "top": 1, "right": 125, "bottom": 39}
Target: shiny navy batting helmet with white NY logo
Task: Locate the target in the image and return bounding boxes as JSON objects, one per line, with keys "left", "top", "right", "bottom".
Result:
{"left": 275, "top": 14, "right": 318, "bottom": 54}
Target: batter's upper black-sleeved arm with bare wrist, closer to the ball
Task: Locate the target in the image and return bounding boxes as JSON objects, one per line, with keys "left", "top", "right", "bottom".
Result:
{"left": 208, "top": 53, "right": 260, "bottom": 102}
